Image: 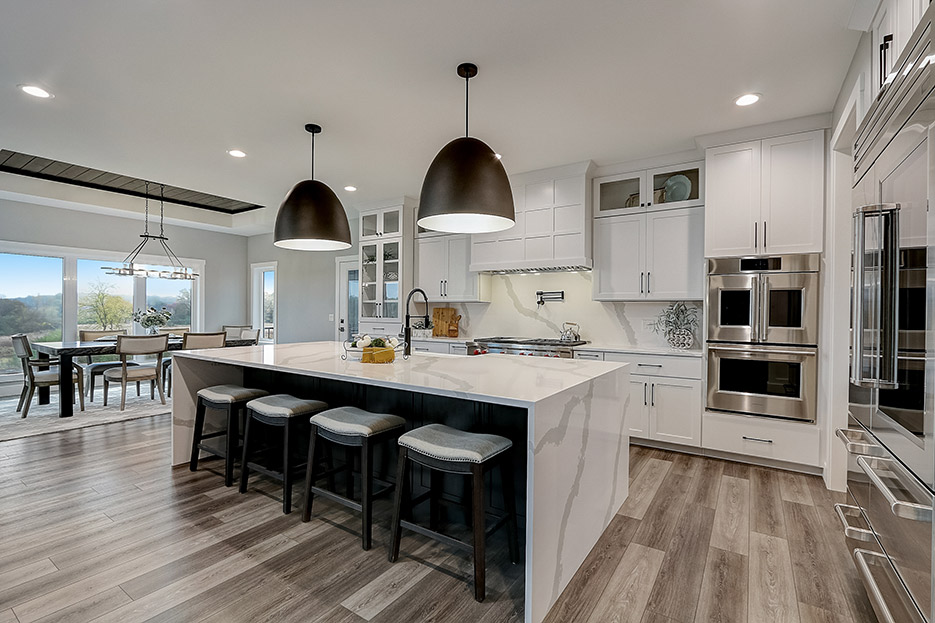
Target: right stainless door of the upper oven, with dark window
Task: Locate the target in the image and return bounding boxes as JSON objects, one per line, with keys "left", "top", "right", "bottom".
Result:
{"left": 759, "top": 273, "right": 818, "bottom": 344}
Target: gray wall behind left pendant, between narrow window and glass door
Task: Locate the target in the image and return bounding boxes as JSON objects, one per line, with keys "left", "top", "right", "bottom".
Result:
{"left": 247, "top": 221, "right": 358, "bottom": 344}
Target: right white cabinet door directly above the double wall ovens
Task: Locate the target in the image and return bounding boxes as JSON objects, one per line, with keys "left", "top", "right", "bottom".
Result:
{"left": 759, "top": 130, "right": 825, "bottom": 254}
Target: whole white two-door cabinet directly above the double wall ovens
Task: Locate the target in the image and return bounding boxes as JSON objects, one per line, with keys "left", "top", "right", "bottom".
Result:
{"left": 704, "top": 130, "right": 825, "bottom": 257}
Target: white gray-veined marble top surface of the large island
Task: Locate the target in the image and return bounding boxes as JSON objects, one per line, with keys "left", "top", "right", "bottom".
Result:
{"left": 175, "top": 342, "right": 626, "bottom": 408}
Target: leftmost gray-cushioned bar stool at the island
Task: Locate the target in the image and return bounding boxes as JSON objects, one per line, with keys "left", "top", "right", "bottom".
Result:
{"left": 188, "top": 385, "right": 269, "bottom": 487}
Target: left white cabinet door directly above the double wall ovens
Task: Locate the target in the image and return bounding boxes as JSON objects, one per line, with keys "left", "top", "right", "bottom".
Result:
{"left": 705, "top": 141, "right": 760, "bottom": 257}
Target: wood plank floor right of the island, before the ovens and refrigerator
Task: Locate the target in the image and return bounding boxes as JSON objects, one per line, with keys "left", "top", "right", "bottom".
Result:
{"left": 546, "top": 446, "right": 876, "bottom": 623}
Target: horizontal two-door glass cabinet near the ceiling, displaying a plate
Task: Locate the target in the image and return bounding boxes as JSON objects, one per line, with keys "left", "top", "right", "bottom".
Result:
{"left": 594, "top": 161, "right": 704, "bottom": 217}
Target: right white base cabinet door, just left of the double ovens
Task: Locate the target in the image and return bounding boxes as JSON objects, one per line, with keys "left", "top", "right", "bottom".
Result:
{"left": 649, "top": 378, "right": 701, "bottom": 446}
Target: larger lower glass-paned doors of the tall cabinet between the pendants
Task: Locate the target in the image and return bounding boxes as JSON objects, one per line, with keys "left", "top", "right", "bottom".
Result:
{"left": 360, "top": 238, "right": 402, "bottom": 320}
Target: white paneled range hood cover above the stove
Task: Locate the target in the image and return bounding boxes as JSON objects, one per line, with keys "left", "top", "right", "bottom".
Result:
{"left": 470, "top": 162, "right": 593, "bottom": 272}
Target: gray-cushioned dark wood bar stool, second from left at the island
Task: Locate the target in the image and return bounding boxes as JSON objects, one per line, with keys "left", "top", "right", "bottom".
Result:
{"left": 240, "top": 394, "right": 328, "bottom": 515}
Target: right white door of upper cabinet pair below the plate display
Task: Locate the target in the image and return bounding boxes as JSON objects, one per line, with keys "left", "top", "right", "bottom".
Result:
{"left": 646, "top": 208, "right": 705, "bottom": 301}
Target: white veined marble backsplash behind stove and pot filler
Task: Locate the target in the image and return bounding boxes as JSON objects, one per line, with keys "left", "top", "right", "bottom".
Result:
{"left": 432, "top": 271, "right": 701, "bottom": 347}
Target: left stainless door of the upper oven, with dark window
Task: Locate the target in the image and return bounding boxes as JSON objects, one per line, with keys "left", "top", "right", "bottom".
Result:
{"left": 706, "top": 275, "right": 759, "bottom": 342}
